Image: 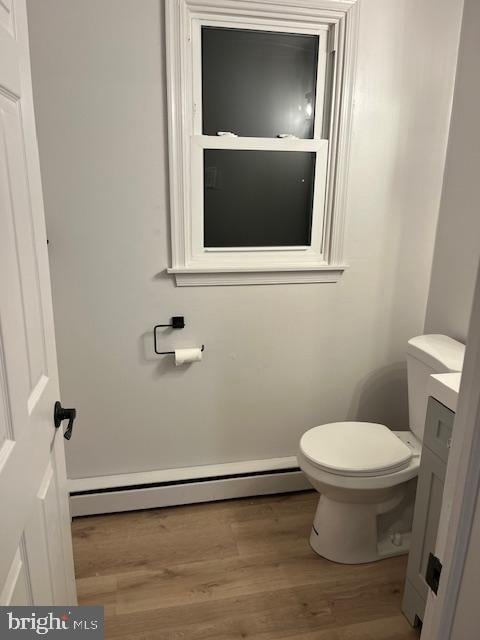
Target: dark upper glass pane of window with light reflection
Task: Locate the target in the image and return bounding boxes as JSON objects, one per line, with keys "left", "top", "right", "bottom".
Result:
{"left": 202, "top": 27, "right": 318, "bottom": 138}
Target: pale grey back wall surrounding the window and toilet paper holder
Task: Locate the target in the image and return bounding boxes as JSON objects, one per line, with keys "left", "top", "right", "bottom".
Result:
{"left": 28, "top": 0, "right": 462, "bottom": 478}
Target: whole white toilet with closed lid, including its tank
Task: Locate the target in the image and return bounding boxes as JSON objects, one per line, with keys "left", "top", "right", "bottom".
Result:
{"left": 298, "top": 335, "right": 465, "bottom": 564}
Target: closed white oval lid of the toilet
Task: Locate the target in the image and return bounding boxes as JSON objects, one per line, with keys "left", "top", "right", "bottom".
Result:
{"left": 300, "top": 422, "right": 412, "bottom": 476}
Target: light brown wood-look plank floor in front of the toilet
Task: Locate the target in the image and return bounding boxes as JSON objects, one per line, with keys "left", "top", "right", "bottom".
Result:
{"left": 73, "top": 492, "right": 417, "bottom": 640}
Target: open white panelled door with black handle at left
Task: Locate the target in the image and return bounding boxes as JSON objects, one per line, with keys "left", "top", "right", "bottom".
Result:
{"left": 0, "top": 0, "right": 76, "bottom": 605}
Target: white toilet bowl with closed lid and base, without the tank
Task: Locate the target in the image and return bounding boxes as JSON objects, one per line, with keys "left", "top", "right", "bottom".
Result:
{"left": 298, "top": 422, "right": 422, "bottom": 564}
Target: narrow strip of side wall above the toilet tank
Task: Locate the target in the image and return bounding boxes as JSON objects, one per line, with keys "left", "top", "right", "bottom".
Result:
{"left": 426, "top": 0, "right": 480, "bottom": 341}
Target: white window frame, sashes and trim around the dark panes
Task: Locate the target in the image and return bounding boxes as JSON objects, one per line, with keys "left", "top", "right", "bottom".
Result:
{"left": 166, "top": 0, "right": 358, "bottom": 286}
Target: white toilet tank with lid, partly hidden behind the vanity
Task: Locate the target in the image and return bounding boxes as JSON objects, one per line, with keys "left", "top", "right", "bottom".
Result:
{"left": 407, "top": 335, "right": 465, "bottom": 441}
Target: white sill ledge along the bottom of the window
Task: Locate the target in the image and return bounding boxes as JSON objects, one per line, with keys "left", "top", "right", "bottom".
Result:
{"left": 167, "top": 264, "right": 347, "bottom": 287}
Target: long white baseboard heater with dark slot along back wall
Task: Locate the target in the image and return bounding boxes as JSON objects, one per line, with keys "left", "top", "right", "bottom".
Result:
{"left": 69, "top": 457, "right": 312, "bottom": 517}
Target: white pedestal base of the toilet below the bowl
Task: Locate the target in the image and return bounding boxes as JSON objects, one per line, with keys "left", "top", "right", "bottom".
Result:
{"left": 310, "top": 494, "right": 410, "bottom": 564}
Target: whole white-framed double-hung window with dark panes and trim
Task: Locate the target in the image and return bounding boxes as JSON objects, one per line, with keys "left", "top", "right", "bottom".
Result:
{"left": 167, "top": 0, "right": 356, "bottom": 285}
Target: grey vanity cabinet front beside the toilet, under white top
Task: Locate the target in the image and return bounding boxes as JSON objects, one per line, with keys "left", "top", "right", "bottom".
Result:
{"left": 402, "top": 397, "right": 455, "bottom": 626}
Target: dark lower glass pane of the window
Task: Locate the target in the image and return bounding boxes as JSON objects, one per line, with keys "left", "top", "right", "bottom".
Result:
{"left": 204, "top": 149, "right": 315, "bottom": 247}
